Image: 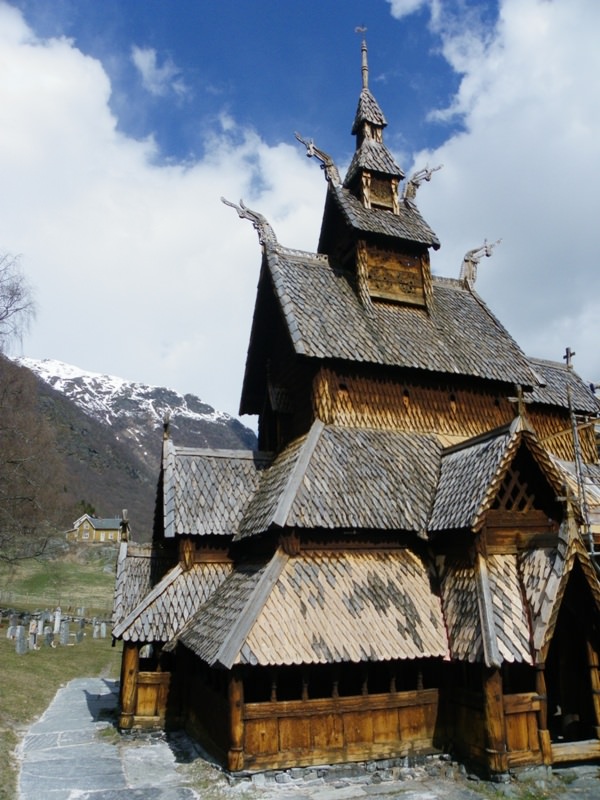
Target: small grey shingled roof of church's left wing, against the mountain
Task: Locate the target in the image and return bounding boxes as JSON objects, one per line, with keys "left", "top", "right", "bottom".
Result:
{"left": 163, "top": 439, "right": 272, "bottom": 538}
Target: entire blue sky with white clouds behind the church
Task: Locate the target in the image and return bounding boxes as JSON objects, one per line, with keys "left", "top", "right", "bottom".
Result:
{"left": 0, "top": 0, "right": 600, "bottom": 422}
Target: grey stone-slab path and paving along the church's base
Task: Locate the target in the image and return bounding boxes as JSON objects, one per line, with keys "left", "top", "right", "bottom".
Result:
{"left": 14, "top": 678, "right": 600, "bottom": 800}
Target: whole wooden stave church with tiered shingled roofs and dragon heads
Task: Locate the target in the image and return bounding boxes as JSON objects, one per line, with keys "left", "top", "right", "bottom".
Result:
{"left": 113, "top": 42, "right": 600, "bottom": 776}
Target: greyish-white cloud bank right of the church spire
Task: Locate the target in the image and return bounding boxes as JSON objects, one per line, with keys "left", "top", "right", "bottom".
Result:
{"left": 406, "top": 0, "right": 600, "bottom": 381}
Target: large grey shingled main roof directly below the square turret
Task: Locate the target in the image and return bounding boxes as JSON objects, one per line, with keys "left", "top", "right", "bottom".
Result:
{"left": 260, "top": 250, "right": 539, "bottom": 386}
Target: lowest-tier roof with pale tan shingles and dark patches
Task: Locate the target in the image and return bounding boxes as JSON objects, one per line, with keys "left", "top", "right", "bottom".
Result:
{"left": 179, "top": 550, "right": 448, "bottom": 668}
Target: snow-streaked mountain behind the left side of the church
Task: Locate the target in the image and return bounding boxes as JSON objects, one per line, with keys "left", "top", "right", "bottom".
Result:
{"left": 13, "top": 358, "right": 256, "bottom": 540}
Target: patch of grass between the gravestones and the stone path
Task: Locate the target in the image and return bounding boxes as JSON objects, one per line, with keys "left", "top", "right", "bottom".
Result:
{"left": 0, "top": 623, "right": 121, "bottom": 800}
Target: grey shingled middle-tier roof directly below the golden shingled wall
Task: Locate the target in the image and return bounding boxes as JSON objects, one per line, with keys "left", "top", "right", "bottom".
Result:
{"left": 238, "top": 420, "right": 440, "bottom": 538}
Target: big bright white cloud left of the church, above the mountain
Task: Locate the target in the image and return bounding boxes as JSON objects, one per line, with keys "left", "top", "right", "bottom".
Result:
{"left": 0, "top": 3, "right": 325, "bottom": 413}
